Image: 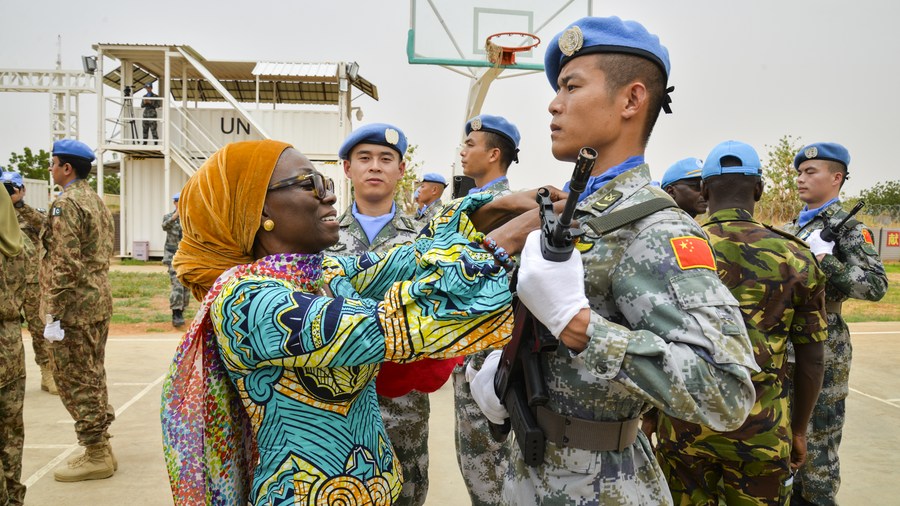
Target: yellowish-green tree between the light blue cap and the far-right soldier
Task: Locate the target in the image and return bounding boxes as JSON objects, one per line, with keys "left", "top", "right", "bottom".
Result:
{"left": 756, "top": 135, "right": 802, "bottom": 226}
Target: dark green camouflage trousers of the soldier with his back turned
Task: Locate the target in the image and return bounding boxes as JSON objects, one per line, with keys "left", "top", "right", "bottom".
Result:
{"left": 656, "top": 448, "right": 791, "bottom": 506}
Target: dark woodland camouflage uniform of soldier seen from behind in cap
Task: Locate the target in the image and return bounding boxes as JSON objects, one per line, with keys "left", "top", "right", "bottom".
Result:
{"left": 657, "top": 209, "right": 827, "bottom": 506}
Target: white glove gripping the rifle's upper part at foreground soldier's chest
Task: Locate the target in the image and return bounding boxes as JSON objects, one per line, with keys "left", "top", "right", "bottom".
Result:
{"left": 516, "top": 230, "right": 588, "bottom": 337}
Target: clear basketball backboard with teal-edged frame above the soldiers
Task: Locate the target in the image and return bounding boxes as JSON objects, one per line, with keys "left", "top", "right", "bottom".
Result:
{"left": 407, "top": 0, "right": 591, "bottom": 71}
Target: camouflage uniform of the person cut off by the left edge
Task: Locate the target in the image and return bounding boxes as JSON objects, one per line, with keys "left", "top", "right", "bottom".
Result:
{"left": 0, "top": 236, "right": 35, "bottom": 505}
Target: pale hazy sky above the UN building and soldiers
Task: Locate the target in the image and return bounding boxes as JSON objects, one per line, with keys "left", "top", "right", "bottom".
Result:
{"left": 0, "top": 0, "right": 900, "bottom": 195}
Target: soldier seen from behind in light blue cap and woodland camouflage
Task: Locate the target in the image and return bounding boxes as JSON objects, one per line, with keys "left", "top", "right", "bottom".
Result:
{"left": 657, "top": 141, "right": 827, "bottom": 506}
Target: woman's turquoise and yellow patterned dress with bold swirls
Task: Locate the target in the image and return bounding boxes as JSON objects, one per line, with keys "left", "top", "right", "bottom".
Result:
{"left": 209, "top": 231, "right": 512, "bottom": 506}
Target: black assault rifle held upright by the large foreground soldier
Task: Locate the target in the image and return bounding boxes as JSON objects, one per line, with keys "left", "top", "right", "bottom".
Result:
{"left": 490, "top": 147, "right": 597, "bottom": 466}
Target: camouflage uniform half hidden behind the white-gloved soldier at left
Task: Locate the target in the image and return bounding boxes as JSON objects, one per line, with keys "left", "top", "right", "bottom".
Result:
{"left": 16, "top": 202, "right": 50, "bottom": 367}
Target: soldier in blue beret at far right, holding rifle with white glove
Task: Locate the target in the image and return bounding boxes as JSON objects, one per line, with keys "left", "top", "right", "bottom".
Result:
{"left": 784, "top": 143, "right": 888, "bottom": 505}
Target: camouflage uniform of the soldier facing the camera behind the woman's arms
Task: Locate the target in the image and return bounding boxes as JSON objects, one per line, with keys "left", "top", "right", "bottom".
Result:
{"left": 325, "top": 203, "right": 431, "bottom": 506}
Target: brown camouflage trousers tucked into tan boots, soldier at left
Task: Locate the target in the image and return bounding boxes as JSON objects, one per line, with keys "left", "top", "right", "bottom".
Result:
{"left": 50, "top": 320, "right": 115, "bottom": 446}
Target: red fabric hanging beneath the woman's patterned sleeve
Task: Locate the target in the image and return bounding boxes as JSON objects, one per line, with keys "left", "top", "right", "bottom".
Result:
{"left": 375, "top": 357, "right": 463, "bottom": 397}
